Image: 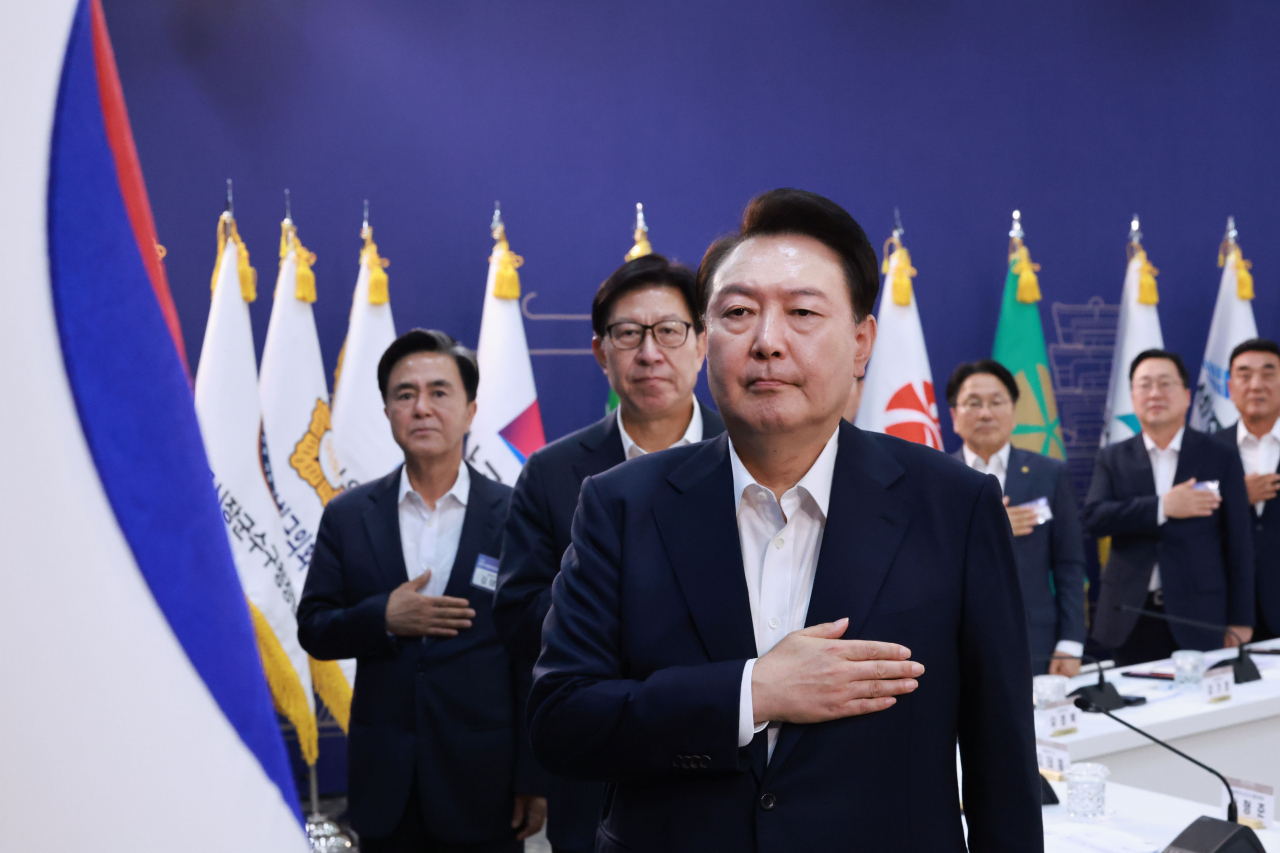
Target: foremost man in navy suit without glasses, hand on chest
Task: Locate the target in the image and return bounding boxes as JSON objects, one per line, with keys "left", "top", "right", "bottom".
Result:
{"left": 530, "top": 190, "right": 1043, "bottom": 853}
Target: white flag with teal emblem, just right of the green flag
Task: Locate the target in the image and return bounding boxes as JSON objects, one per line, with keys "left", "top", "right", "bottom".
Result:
{"left": 1102, "top": 247, "right": 1165, "bottom": 447}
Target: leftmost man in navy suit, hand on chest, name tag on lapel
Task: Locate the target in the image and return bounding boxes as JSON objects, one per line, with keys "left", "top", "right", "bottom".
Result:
{"left": 298, "top": 329, "right": 547, "bottom": 853}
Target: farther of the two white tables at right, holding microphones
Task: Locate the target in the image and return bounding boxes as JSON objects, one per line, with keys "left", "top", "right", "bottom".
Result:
{"left": 1053, "top": 640, "right": 1280, "bottom": 807}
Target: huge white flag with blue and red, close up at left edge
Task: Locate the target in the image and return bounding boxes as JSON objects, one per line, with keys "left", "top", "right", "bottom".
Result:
{"left": 0, "top": 0, "right": 307, "bottom": 853}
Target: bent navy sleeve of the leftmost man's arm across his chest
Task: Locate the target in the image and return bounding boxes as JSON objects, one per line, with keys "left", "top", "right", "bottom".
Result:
{"left": 298, "top": 508, "right": 396, "bottom": 661}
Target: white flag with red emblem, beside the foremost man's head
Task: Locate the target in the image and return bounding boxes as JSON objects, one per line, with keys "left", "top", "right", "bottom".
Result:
{"left": 856, "top": 232, "right": 942, "bottom": 450}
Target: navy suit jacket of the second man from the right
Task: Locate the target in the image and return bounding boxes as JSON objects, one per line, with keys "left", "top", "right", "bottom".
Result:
{"left": 1084, "top": 427, "right": 1254, "bottom": 651}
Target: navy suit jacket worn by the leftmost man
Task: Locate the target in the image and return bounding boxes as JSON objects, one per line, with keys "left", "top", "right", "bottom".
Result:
{"left": 298, "top": 466, "right": 541, "bottom": 844}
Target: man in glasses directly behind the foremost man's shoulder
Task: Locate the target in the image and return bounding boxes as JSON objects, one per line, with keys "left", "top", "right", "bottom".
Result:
{"left": 493, "top": 255, "right": 724, "bottom": 853}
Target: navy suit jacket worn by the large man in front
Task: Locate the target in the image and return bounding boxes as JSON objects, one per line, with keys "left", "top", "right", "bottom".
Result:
{"left": 530, "top": 423, "right": 1043, "bottom": 853}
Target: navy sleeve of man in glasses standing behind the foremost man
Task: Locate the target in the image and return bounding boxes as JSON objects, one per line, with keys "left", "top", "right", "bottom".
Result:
{"left": 493, "top": 450, "right": 562, "bottom": 671}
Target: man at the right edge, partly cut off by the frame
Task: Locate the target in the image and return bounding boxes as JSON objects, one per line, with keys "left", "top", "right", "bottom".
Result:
{"left": 1215, "top": 338, "right": 1280, "bottom": 640}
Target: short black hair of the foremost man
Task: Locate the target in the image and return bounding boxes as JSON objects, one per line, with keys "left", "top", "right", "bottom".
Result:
{"left": 698, "top": 188, "right": 879, "bottom": 320}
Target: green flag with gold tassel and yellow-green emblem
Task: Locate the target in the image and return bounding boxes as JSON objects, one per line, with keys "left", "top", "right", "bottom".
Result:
{"left": 991, "top": 237, "right": 1066, "bottom": 459}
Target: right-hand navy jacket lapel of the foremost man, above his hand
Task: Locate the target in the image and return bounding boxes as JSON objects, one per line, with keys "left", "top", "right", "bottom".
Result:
{"left": 769, "top": 421, "right": 911, "bottom": 770}
